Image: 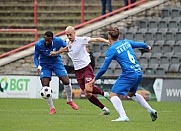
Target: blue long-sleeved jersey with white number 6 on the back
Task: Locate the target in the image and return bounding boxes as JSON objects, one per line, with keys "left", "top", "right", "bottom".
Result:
{"left": 96, "top": 40, "right": 149, "bottom": 79}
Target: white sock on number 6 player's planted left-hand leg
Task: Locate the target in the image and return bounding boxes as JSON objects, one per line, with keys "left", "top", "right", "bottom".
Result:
{"left": 110, "top": 96, "right": 126, "bottom": 117}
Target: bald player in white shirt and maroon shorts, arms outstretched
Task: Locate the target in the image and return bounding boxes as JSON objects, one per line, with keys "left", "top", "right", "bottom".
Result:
{"left": 51, "top": 26, "right": 110, "bottom": 115}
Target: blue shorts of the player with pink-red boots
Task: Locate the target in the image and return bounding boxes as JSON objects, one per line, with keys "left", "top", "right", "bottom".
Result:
{"left": 40, "top": 63, "right": 68, "bottom": 79}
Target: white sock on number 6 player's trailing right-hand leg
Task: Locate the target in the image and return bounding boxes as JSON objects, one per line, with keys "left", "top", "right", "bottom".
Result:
{"left": 131, "top": 93, "right": 152, "bottom": 112}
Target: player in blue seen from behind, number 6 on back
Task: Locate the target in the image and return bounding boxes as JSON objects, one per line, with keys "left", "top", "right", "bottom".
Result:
{"left": 90, "top": 27, "right": 157, "bottom": 122}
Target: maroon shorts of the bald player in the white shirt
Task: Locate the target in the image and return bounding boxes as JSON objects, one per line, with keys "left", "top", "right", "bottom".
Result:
{"left": 75, "top": 64, "right": 94, "bottom": 90}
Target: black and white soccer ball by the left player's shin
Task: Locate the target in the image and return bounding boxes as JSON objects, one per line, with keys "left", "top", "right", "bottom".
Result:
{"left": 40, "top": 86, "right": 53, "bottom": 99}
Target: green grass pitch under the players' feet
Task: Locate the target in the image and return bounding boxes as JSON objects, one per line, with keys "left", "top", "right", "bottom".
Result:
{"left": 0, "top": 98, "right": 181, "bottom": 131}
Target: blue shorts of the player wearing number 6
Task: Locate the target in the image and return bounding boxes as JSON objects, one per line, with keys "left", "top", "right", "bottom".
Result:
{"left": 111, "top": 73, "right": 142, "bottom": 96}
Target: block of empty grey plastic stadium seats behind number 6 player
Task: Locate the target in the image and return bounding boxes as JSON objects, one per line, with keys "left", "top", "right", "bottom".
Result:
{"left": 92, "top": 7, "right": 181, "bottom": 76}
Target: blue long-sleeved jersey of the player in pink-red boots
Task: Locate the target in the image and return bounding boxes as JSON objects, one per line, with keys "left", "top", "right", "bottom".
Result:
{"left": 34, "top": 37, "right": 67, "bottom": 67}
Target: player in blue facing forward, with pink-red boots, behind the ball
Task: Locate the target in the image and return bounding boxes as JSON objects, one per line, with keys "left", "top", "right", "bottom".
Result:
{"left": 34, "top": 31, "right": 78, "bottom": 114}
